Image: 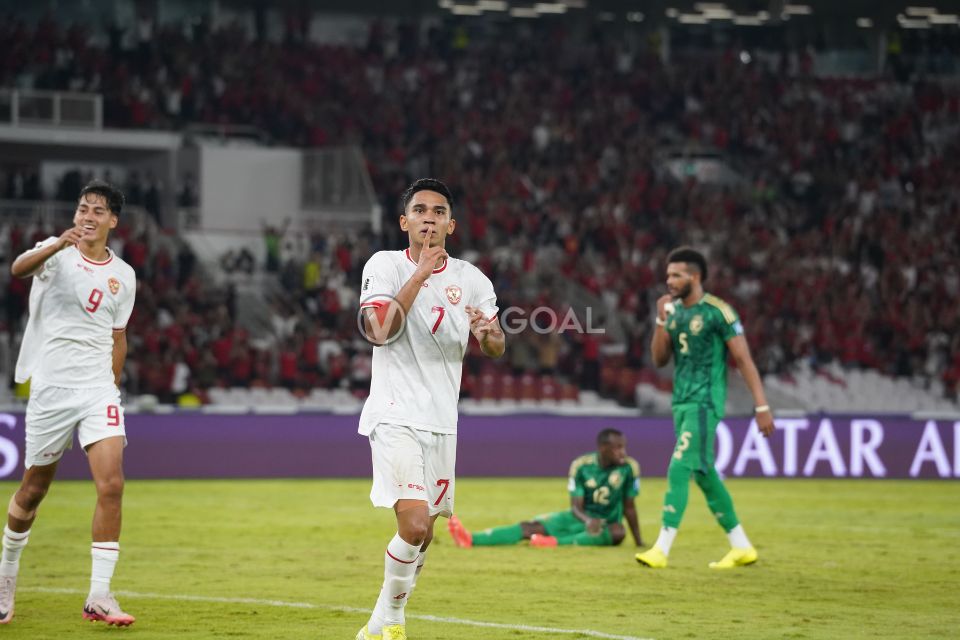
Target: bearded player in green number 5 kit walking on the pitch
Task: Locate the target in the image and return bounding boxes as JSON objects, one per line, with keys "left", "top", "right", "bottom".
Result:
{"left": 636, "top": 247, "right": 774, "bottom": 569}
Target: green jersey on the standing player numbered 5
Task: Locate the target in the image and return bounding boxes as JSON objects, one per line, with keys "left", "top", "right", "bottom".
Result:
{"left": 667, "top": 293, "right": 743, "bottom": 418}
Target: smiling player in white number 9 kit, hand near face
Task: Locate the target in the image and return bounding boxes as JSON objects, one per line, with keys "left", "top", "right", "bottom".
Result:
{"left": 0, "top": 181, "right": 137, "bottom": 626}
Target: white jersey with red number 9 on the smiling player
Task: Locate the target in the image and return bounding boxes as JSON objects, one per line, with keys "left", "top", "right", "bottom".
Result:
{"left": 16, "top": 238, "right": 137, "bottom": 389}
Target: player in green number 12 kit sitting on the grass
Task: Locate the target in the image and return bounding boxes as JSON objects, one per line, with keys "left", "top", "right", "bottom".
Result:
{"left": 447, "top": 429, "right": 643, "bottom": 547}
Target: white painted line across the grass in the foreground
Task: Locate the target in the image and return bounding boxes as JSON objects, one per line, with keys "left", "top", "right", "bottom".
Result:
{"left": 18, "top": 587, "right": 653, "bottom": 640}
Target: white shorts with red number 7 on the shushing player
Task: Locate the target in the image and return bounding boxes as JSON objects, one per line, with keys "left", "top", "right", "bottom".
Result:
{"left": 369, "top": 423, "right": 457, "bottom": 518}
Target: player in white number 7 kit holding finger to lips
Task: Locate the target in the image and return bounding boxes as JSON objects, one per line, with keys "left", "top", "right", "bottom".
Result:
{"left": 356, "top": 179, "right": 505, "bottom": 640}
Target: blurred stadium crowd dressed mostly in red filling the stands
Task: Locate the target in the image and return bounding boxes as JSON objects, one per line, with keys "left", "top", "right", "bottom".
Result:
{"left": 0, "top": 13, "right": 960, "bottom": 402}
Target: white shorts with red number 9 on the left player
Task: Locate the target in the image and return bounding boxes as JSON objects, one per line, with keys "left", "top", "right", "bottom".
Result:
{"left": 23, "top": 384, "right": 127, "bottom": 469}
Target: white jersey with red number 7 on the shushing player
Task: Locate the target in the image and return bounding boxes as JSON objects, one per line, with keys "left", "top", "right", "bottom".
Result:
{"left": 359, "top": 249, "right": 497, "bottom": 435}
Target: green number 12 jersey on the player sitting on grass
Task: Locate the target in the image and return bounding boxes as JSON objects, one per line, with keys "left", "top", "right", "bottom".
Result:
{"left": 568, "top": 452, "right": 640, "bottom": 522}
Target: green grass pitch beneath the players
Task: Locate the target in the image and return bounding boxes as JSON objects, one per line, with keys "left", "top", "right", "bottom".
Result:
{"left": 0, "top": 478, "right": 960, "bottom": 640}
